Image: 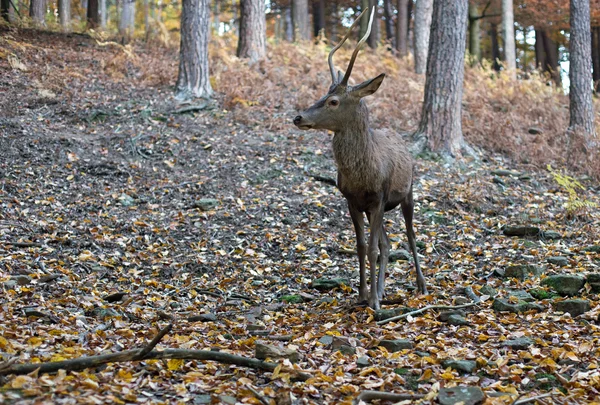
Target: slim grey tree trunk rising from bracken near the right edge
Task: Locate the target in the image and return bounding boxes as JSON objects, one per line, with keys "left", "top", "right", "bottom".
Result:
{"left": 569, "top": 0, "right": 596, "bottom": 145}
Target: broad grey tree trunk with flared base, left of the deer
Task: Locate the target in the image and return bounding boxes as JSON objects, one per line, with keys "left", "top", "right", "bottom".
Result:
{"left": 175, "top": 0, "right": 213, "bottom": 100}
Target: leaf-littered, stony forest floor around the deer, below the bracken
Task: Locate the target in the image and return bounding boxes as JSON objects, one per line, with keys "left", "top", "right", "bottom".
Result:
{"left": 0, "top": 26, "right": 600, "bottom": 404}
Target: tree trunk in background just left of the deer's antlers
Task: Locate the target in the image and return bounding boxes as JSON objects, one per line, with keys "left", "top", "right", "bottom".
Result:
{"left": 237, "top": 0, "right": 267, "bottom": 63}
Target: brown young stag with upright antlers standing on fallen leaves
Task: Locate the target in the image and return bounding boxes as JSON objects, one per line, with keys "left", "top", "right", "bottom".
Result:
{"left": 293, "top": 8, "right": 427, "bottom": 310}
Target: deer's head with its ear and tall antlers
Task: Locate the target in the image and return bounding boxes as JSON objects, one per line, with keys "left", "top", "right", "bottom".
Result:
{"left": 294, "top": 8, "right": 385, "bottom": 131}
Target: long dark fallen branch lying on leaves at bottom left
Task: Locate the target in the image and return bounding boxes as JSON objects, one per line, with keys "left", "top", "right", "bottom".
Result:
{"left": 0, "top": 349, "right": 311, "bottom": 381}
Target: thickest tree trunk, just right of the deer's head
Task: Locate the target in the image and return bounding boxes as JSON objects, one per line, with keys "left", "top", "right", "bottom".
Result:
{"left": 415, "top": 0, "right": 469, "bottom": 157}
